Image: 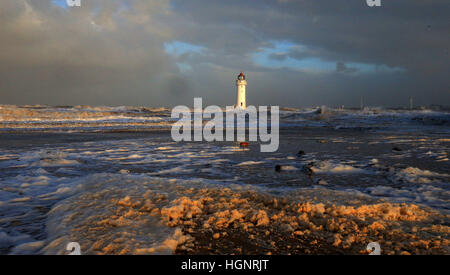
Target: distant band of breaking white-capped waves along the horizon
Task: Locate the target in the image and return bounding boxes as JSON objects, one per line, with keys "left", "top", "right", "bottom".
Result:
{"left": 0, "top": 105, "right": 450, "bottom": 131}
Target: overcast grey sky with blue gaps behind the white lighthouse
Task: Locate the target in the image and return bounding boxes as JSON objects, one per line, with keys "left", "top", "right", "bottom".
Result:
{"left": 0, "top": 0, "right": 450, "bottom": 107}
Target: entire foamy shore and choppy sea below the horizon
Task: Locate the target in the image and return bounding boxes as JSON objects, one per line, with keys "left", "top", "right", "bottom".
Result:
{"left": 0, "top": 106, "right": 450, "bottom": 255}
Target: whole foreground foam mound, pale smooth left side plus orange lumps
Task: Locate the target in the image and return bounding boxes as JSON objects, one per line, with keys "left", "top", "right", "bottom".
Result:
{"left": 40, "top": 175, "right": 450, "bottom": 254}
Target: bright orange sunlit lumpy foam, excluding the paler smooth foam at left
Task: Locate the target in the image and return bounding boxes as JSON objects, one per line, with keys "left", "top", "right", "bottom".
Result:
{"left": 135, "top": 188, "right": 448, "bottom": 254}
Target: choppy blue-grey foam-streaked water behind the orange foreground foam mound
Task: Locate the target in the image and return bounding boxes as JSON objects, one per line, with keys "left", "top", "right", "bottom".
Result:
{"left": 0, "top": 106, "right": 450, "bottom": 254}
